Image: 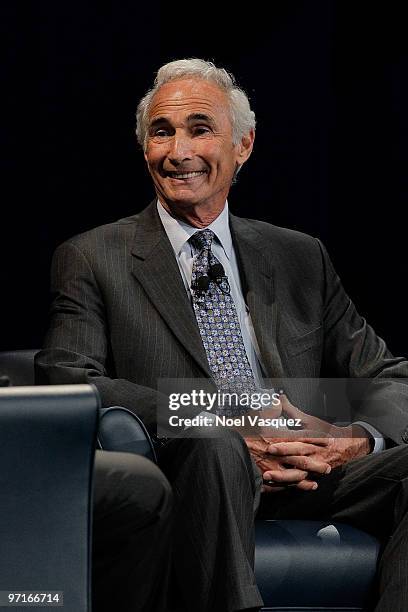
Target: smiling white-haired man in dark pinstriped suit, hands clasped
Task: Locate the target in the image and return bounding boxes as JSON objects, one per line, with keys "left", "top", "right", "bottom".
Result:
{"left": 37, "top": 59, "right": 408, "bottom": 612}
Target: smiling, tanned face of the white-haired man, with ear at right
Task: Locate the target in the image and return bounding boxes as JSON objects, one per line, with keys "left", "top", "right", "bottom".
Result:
{"left": 145, "top": 78, "right": 254, "bottom": 224}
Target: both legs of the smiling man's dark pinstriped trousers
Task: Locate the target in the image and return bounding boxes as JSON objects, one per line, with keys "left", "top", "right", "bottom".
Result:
{"left": 159, "top": 430, "right": 408, "bottom": 612}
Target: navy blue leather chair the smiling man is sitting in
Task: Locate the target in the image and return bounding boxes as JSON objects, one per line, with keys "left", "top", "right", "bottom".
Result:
{"left": 0, "top": 351, "right": 380, "bottom": 612}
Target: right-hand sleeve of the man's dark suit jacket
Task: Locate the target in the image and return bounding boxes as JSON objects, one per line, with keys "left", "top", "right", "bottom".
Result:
{"left": 319, "top": 242, "right": 408, "bottom": 446}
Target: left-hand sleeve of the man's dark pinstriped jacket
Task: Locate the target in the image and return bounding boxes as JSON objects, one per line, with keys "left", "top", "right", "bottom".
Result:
{"left": 35, "top": 242, "right": 164, "bottom": 428}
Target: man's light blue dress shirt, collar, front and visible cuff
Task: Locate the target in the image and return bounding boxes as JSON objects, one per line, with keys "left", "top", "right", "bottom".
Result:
{"left": 157, "top": 200, "right": 385, "bottom": 452}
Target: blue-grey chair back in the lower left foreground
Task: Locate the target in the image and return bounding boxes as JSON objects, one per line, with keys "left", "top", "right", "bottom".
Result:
{"left": 0, "top": 385, "right": 99, "bottom": 612}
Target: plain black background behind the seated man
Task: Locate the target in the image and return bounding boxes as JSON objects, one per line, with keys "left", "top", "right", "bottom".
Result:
{"left": 0, "top": 0, "right": 408, "bottom": 354}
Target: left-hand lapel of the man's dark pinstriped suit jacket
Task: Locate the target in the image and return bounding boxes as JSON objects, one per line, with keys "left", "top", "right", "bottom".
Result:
{"left": 132, "top": 201, "right": 212, "bottom": 378}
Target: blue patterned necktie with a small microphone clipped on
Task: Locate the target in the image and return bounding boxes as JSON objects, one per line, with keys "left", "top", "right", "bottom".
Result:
{"left": 190, "top": 229, "right": 255, "bottom": 414}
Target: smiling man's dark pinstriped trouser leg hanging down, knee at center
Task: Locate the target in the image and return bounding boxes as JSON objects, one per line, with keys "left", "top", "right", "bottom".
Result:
{"left": 159, "top": 428, "right": 263, "bottom": 612}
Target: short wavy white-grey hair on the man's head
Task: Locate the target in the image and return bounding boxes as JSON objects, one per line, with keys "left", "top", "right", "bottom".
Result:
{"left": 136, "top": 58, "right": 255, "bottom": 149}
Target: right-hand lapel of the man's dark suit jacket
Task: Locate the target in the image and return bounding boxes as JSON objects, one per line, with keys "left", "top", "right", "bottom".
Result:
{"left": 230, "top": 215, "right": 283, "bottom": 378}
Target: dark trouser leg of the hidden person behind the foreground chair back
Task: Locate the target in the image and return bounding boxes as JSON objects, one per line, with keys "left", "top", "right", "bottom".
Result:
{"left": 92, "top": 451, "right": 172, "bottom": 612}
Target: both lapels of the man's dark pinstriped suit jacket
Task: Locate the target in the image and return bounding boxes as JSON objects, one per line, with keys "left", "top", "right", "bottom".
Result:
{"left": 132, "top": 201, "right": 283, "bottom": 378}
